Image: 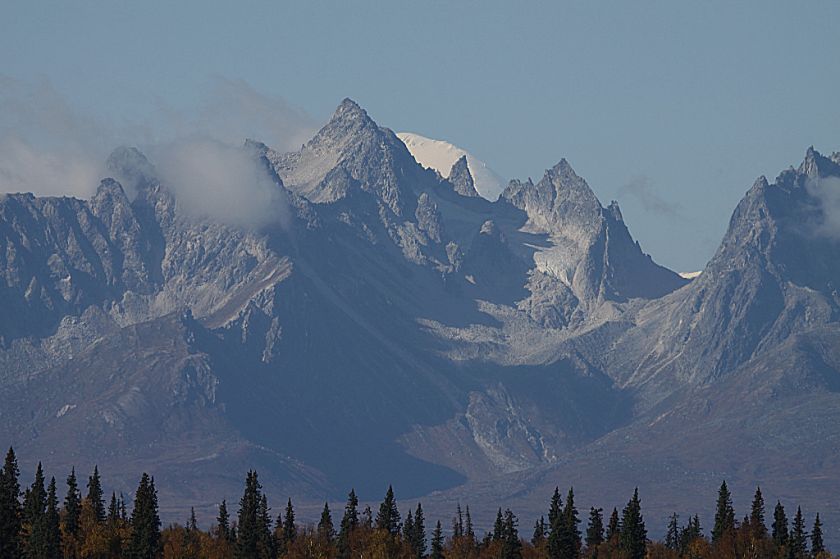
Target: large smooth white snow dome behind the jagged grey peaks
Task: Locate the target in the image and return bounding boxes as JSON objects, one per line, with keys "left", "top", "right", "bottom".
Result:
{"left": 397, "top": 132, "right": 505, "bottom": 201}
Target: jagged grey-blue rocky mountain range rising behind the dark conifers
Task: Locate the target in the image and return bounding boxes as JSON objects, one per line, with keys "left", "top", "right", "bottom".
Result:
{"left": 0, "top": 99, "right": 840, "bottom": 542}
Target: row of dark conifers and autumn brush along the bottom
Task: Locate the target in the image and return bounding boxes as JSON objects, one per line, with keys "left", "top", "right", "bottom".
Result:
{"left": 0, "top": 448, "right": 831, "bottom": 559}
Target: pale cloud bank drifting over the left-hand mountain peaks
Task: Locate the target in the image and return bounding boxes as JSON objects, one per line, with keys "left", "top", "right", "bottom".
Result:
{"left": 0, "top": 76, "right": 316, "bottom": 226}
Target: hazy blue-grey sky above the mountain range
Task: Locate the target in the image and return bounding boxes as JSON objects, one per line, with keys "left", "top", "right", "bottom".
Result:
{"left": 0, "top": 0, "right": 840, "bottom": 271}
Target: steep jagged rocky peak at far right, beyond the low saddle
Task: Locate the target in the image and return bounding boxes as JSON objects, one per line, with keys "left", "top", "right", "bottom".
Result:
{"left": 632, "top": 144, "right": 840, "bottom": 390}
